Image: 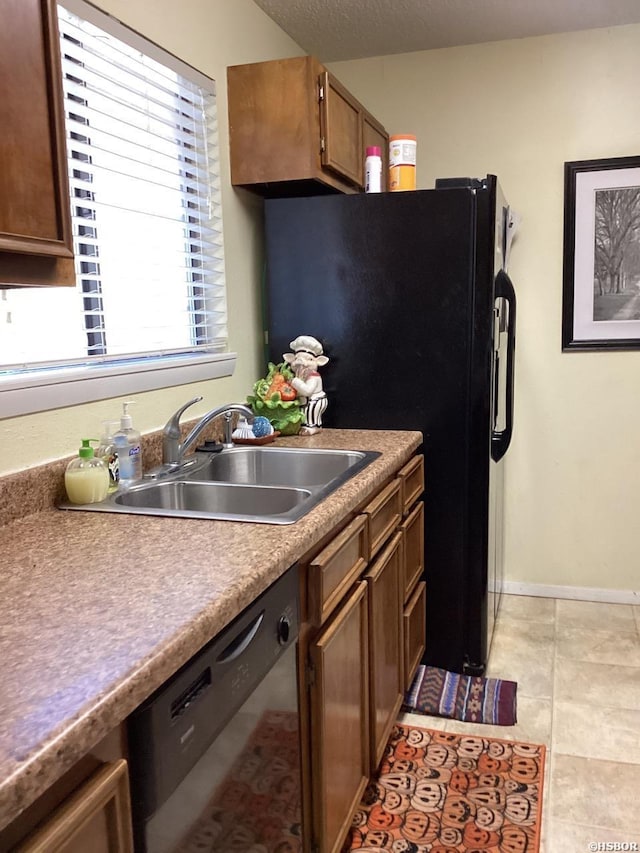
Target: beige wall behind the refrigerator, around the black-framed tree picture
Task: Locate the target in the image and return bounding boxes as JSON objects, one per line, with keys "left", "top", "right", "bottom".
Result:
{"left": 332, "top": 25, "right": 640, "bottom": 590}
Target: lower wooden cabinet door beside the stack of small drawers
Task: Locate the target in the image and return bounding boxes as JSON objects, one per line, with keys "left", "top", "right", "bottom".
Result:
{"left": 364, "top": 533, "right": 404, "bottom": 773}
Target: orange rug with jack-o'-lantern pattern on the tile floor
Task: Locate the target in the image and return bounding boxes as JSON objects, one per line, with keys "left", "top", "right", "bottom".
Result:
{"left": 343, "top": 725, "right": 545, "bottom": 853}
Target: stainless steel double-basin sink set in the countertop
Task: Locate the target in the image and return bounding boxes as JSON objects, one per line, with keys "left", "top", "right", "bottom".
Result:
{"left": 63, "top": 447, "right": 380, "bottom": 524}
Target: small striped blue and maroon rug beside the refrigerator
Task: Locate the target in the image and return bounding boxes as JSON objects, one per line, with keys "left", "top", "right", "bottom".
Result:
{"left": 404, "top": 666, "right": 517, "bottom": 726}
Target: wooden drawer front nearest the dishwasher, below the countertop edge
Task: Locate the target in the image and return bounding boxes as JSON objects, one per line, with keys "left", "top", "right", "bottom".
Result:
{"left": 307, "top": 515, "right": 368, "bottom": 627}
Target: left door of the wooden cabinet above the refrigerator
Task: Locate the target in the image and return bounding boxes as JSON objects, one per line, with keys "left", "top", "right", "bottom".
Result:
{"left": 320, "top": 71, "right": 364, "bottom": 187}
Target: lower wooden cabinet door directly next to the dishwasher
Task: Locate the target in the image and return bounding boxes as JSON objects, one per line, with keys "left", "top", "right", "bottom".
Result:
{"left": 309, "top": 581, "right": 369, "bottom": 853}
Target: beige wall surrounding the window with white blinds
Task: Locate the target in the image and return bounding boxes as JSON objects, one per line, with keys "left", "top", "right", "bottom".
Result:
{"left": 0, "top": 0, "right": 304, "bottom": 475}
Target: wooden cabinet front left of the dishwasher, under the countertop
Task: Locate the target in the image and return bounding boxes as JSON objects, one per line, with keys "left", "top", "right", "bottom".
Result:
{"left": 14, "top": 759, "right": 133, "bottom": 853}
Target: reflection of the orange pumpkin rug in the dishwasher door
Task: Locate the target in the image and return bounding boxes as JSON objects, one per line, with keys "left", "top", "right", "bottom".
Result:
{"left": 177, "top": 711, "right": 302, "bottom": 853}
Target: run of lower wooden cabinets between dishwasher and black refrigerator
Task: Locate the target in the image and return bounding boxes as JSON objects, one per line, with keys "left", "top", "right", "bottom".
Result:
{"left": 299, "top": 456, "right": 425, "bottom": 853}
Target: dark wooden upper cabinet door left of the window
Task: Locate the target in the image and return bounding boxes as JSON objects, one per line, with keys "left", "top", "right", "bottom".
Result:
{"left": 0, "top": 0, "right": 73, "bottom": 258}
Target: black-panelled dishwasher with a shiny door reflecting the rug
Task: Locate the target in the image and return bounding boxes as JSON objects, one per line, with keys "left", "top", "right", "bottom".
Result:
{"left": 128, "top": 567, "right": 302, "bottom": 853}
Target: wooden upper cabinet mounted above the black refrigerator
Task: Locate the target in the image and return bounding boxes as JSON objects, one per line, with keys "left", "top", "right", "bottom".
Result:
{"left": 227, "top": 56, "right": 388, "bottom": 197}
